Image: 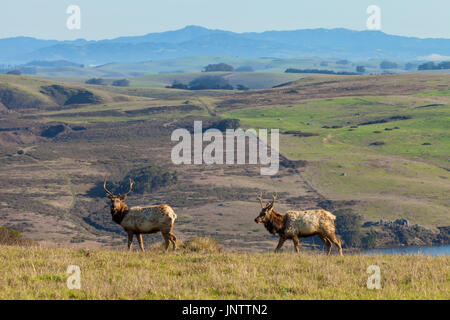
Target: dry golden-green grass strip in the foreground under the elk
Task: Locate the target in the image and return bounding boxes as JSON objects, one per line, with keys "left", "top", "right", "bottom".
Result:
{"left": 0, "top": 240, "right": 450, "bottom": 300}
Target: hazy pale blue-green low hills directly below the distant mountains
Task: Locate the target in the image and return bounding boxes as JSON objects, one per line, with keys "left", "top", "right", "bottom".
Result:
{"left": 14, "top": 55, "right": 432, "bottom": 78}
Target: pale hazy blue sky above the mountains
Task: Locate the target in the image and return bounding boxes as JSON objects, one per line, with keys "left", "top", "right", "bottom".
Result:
{"left": 0, "top": 0, "right": 450, "bottom": 40}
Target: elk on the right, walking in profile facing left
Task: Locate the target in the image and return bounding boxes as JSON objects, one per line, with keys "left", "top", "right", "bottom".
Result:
{"left": 255, "top": 193, "right": 342, "bottom": 256}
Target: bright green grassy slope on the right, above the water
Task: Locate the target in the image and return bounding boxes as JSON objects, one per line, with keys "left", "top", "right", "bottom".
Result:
{"left": 221, "top": 75, "right": 450, "bottom": 224}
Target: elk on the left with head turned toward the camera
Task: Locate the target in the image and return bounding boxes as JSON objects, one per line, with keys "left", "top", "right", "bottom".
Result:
{"left": 103, "top": 179, "right": 177, "bottom": 251}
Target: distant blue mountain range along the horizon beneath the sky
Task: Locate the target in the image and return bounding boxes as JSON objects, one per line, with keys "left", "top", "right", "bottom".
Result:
{"left": 0, "top": 26, "right": 450, "bottom": 65}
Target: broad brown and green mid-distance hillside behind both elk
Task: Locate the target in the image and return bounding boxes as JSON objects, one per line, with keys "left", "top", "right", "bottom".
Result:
{"left": 0, "top": 73, "right": 450, "bottom": 251}
